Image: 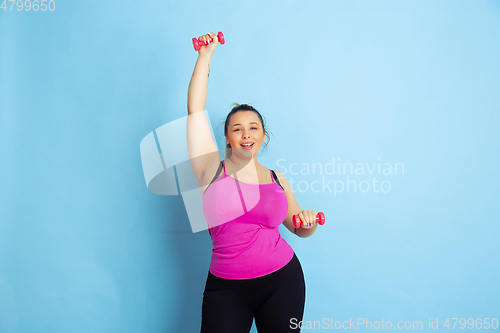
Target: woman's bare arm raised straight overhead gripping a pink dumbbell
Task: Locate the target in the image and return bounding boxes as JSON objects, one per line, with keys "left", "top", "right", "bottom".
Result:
{"left": 187, "top": 33, "right": 220, "bottom": 187}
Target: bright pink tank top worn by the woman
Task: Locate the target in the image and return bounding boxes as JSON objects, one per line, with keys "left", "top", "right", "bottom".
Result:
{"left": 203, "top": 160, "right": 294, "bottom": 280}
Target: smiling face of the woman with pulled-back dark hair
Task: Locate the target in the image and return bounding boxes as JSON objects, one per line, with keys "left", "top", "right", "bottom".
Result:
{"left": 225, "top": 111, "right": 266, "bottom": 158}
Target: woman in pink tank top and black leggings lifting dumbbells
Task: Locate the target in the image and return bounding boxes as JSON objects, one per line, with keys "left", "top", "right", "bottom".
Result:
{"left": 187, "top": 33, "right": 317, "bottom": 333}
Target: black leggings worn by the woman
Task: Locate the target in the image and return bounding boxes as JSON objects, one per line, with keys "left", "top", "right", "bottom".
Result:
{"left": 201, "top": 253, "right": 306, "bottom": 333}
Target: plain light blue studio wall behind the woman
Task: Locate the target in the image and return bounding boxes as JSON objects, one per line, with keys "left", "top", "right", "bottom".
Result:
{"left": 0, "top": 0, "right": 500, "bottom": 333}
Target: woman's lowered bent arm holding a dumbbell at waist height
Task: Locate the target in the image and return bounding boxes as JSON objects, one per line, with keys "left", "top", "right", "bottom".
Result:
{"left": 274, "top": 170, "right": 318, "bottom": 238}
